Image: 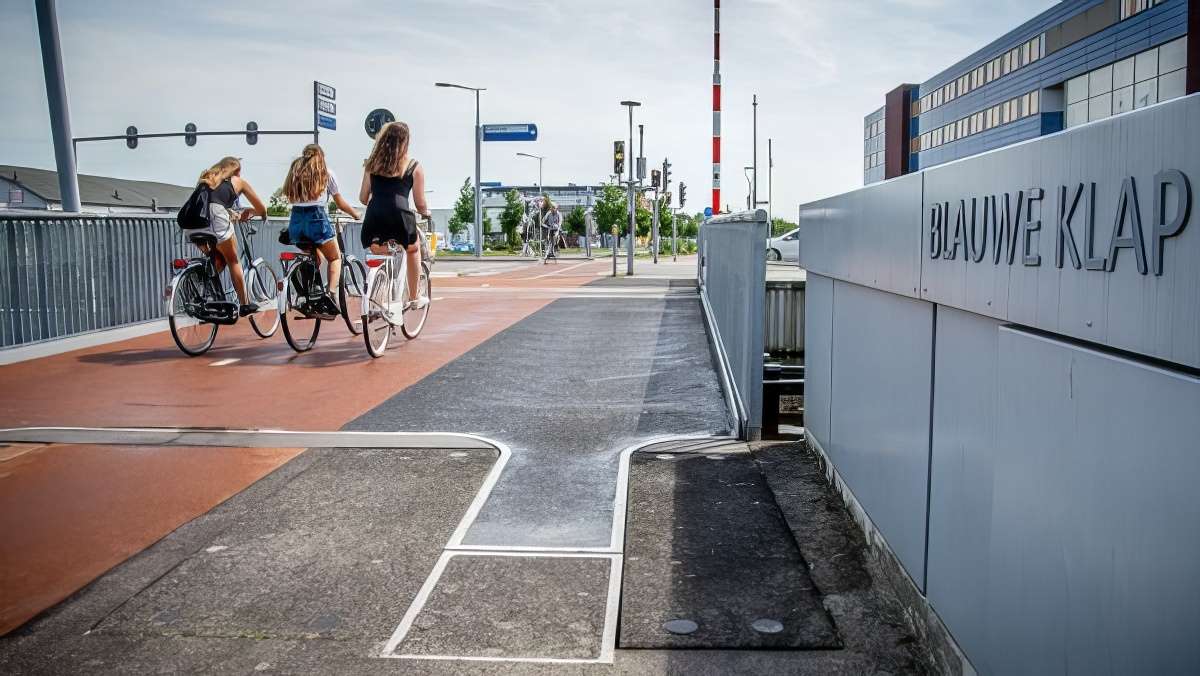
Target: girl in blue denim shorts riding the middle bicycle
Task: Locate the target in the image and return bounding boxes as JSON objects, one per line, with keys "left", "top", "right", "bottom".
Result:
{"left": 283, "top": 143, "right": 359, "bottom": 315}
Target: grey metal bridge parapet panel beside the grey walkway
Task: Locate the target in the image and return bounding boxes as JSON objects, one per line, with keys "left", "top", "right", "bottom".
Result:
{"left": 697, "top": 209, "right": 768, "bottom": 439}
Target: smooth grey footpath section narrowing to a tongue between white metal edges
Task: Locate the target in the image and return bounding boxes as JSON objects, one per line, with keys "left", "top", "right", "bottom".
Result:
{"left": 346, "top": 298, "right": 728, "bottom": 548}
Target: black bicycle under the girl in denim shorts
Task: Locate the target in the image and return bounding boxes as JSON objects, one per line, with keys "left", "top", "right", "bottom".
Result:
{"left": 278, "top": 221, "right": 367, "bottom": 352}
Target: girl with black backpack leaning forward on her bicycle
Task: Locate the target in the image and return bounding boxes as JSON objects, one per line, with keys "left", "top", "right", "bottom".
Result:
{"left": 194, "top": 157, "right": 266, "bottom": 317}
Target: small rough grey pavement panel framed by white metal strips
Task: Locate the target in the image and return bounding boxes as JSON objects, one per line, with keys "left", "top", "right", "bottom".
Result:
{"left": 395, "top": 555, "right": 616, "bottom": 660}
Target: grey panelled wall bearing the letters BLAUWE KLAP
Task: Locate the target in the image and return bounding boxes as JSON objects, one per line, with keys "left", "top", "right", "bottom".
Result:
{"left": 800, "top": 96, "right": 1200, "bottom": 674}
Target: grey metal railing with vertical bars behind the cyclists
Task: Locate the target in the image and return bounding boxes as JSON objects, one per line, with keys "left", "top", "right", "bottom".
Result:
{"left": 0, "top": 215, "right": 364, "bottom": 348}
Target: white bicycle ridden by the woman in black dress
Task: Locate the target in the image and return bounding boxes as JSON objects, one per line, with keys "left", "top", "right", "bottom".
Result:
{"left": 362, "top": 234, "right": 433, "bottom": 359}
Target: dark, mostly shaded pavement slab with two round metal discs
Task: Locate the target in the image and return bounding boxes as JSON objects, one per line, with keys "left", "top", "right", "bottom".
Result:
{"left": 619, "top": 444, "right": 841, "bottom": 648}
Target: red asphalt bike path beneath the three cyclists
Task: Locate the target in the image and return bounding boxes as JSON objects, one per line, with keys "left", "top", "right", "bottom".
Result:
{"left": 0, "top": 262, "right": 611, "bottom": 635}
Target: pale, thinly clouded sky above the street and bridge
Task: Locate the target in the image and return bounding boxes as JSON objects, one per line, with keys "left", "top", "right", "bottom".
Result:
{"left": 0, "top": 0, "right": 1054, "bottom": 220}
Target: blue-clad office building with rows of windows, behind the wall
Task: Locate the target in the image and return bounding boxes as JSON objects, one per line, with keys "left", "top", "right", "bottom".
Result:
{"left": 863, "top": 0, "right": 1200, "bottom": 184}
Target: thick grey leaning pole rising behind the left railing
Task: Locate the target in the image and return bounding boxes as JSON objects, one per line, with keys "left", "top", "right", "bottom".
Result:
{"left": 34, "top": 0, "right": 83, "bottom": 213}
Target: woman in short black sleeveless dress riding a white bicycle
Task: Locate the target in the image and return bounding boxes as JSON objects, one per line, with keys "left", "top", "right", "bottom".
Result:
{"left": 359, "top": 121, "right": 430, "bottom": 310}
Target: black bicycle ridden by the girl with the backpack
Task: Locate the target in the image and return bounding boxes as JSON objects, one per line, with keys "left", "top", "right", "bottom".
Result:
{"left": 166, "top": 221, "right": 280, "bottom": 357}
